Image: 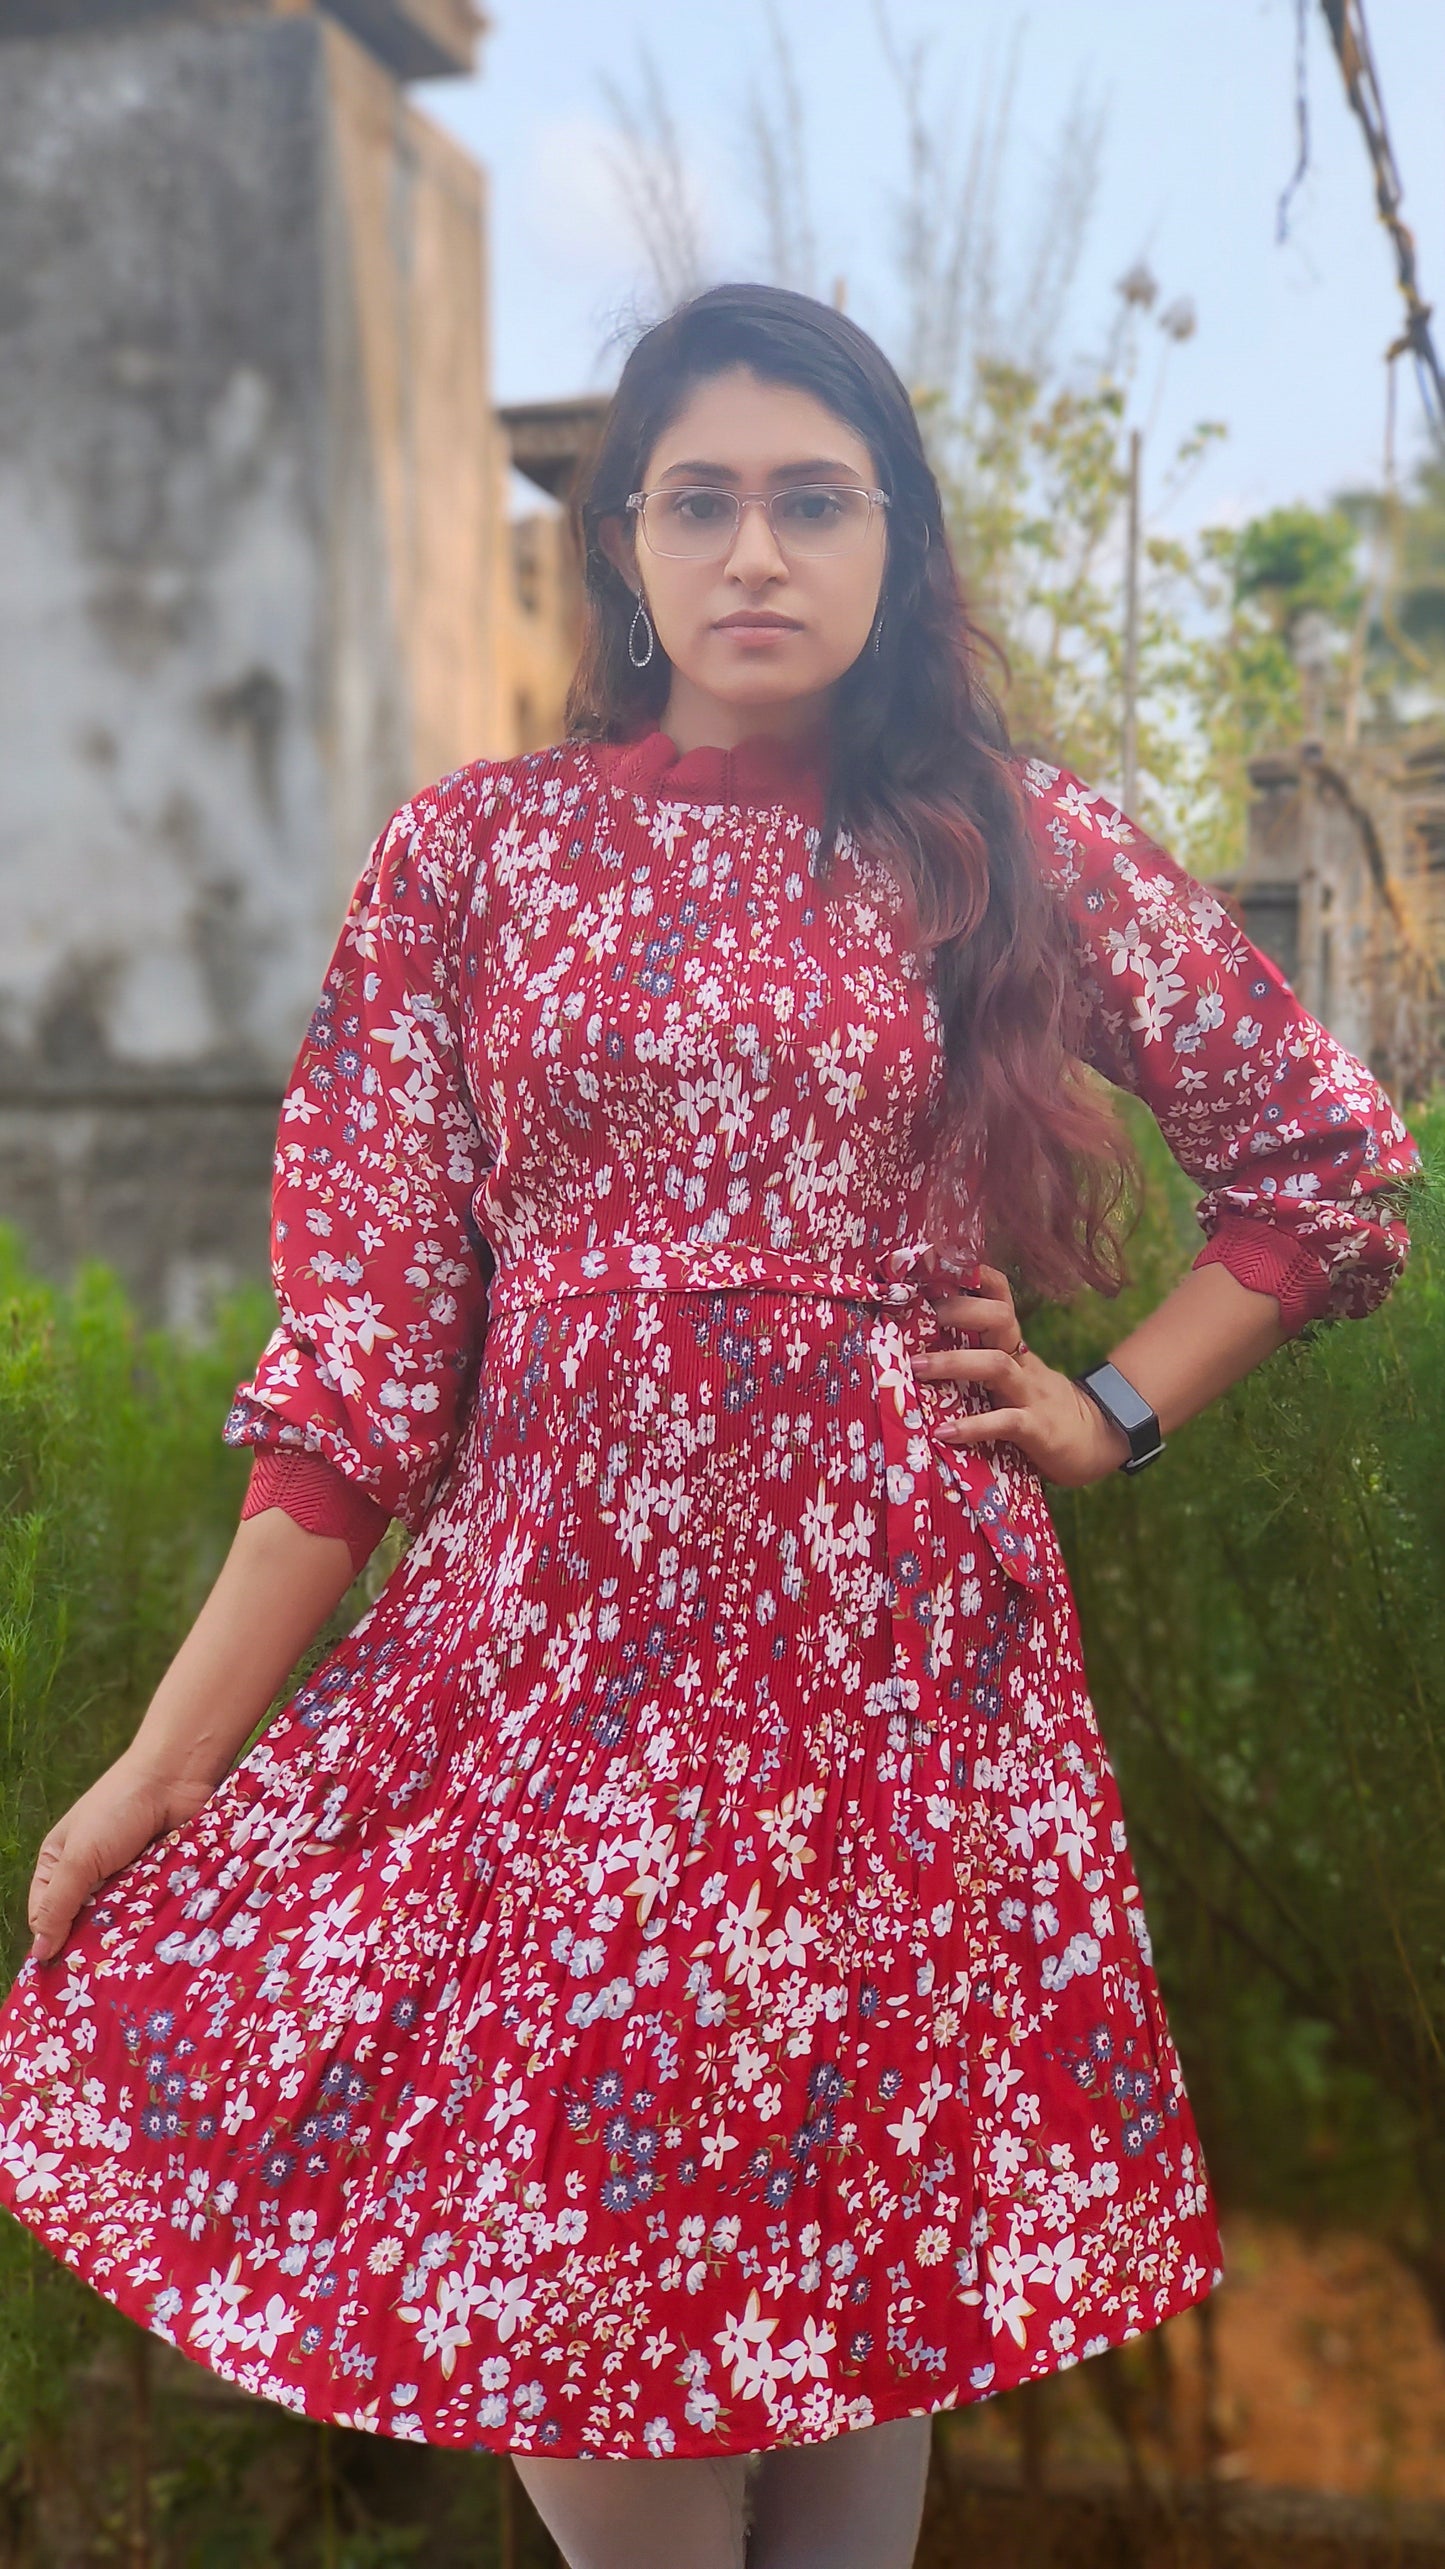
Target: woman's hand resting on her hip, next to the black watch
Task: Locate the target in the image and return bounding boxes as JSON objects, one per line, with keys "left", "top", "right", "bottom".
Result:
{"left": 913, "top": 1267, "right": 1129, "bottom": 1490}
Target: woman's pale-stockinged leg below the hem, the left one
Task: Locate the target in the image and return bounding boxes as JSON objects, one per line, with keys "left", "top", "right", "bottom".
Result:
{"left": 512, "top": 2453, "right": 745, "bottom": 2569}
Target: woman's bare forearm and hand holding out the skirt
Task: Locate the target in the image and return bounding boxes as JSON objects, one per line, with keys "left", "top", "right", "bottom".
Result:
{"left": 28, "top": 1508, "right": 352, "bottom": 1963}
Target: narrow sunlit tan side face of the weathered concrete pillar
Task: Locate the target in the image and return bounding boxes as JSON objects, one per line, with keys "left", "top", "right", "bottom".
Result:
{"left": 319, "top": 23, "right": 512, "bottom": 891}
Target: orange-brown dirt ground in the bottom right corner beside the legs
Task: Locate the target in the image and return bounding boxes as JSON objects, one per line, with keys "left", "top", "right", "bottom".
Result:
{"left": 918, "top": 2220, "right": 1445, "bottom": 2569}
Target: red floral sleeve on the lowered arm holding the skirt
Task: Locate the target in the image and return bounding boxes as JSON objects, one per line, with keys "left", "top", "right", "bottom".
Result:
{"left": 221, "top": 786, "right": 491, "bottom": 1531}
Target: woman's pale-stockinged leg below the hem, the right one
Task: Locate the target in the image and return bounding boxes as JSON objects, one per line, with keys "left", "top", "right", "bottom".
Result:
{"left": 740, "top": 2417, "right": 933, "bottom": 2569}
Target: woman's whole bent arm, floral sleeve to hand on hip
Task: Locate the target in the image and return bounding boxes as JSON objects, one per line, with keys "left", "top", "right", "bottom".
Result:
{"left": 915, "top": 760, "right": 1419, "bottom": 1487}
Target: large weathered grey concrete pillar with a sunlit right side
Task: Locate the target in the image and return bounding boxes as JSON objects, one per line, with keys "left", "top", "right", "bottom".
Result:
{"left": 0, "top": 0, "right": 509, "bottom": 1315}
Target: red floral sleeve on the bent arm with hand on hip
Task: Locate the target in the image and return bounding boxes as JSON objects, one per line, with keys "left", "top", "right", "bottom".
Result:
{"left": 1021, "top": 760, "right": 1419, "bottom": 1336}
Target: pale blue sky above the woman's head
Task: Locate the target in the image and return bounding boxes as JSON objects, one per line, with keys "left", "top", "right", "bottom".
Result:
{"left": 417, "top": 0, "right": 1445, "bottom": 536}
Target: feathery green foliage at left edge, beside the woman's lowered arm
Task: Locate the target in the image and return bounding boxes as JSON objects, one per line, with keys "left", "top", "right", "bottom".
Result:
{"left": 0, "top": 1233, "right": 273, "bottom": 2464}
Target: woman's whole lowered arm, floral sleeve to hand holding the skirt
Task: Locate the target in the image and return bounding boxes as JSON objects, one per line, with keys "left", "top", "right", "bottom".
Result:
{"left": 31, "top": 763, "right": 509, "bottom": 1960}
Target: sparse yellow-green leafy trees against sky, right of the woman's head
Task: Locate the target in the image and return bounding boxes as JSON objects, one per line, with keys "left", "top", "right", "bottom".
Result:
{"left": 918, "top": 360, "right": 1445, "bottom": 876}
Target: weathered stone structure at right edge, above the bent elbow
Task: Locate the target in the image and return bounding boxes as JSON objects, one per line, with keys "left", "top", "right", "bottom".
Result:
{"left": 1214, "top": 735, "right": 1445, "bottom": 1100}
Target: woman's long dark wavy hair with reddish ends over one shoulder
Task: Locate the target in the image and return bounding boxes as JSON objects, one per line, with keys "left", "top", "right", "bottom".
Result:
{"left": 566, "top": 285, "right": 1129, "bottom": 1295}
